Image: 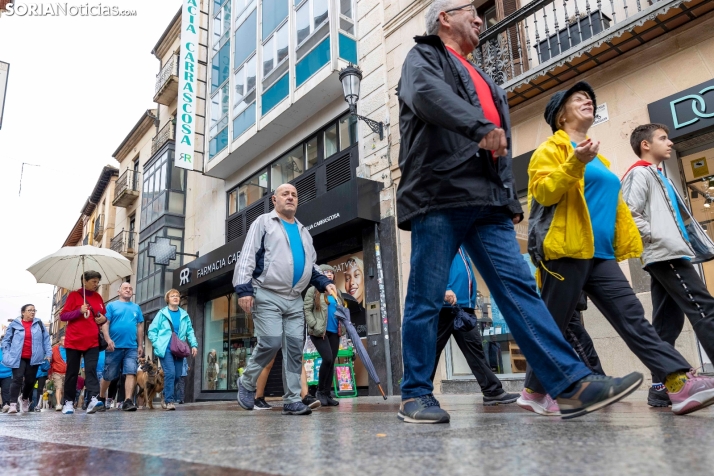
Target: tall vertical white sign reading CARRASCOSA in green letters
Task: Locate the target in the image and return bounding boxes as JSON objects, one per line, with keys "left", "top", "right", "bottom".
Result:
{"left": 174, "top": 0, "right": 201, "bottom": 170}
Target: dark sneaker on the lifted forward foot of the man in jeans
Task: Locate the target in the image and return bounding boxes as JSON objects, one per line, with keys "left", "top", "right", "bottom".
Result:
{"left": 557, "top": 372, "right": 643, "bottom": 420}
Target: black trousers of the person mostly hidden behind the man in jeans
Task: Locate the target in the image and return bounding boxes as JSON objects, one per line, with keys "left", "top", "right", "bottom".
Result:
{"left": 431, "top": 308, "right": 503, "bottom": 397}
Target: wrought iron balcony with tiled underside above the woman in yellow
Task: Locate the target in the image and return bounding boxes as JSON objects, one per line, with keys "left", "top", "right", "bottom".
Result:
{"left": 473, "top": 0, "right": 714, "bottom": 106}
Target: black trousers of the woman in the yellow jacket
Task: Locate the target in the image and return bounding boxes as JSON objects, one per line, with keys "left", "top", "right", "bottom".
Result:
{"left": 525, "top": 258, "right": 690, "bottom": 393}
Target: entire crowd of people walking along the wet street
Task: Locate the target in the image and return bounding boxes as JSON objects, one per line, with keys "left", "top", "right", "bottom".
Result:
{"left": 0, "top": 0, "right": 714, "bottom": 423}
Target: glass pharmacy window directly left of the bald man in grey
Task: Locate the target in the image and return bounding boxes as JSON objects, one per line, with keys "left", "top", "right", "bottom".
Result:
{"left": 201, "top": 293, "right": 257, "bottom": 391}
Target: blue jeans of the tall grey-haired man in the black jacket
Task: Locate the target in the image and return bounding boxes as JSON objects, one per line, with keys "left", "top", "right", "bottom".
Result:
{"left": 402, "top": 207, "right": 591, "bottom": 400}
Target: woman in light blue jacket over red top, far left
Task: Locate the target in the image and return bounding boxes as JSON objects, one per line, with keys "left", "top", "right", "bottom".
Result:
{"left": 2, "top": 304, "right": 52, "bottom": 413}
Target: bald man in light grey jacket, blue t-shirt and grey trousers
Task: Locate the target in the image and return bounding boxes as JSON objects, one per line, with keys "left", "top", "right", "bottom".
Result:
{"left": 233, "top": 184, "right": 337, "bottom": 415}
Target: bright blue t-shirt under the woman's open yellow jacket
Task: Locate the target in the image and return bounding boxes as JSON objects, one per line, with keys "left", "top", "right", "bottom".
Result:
{"left": 573, "top": 148, "right": 620, "bottom": 259}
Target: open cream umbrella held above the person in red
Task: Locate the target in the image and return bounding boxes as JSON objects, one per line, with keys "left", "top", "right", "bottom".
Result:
{"left": 27, "top": 245, "right": 132, "bottom": 317}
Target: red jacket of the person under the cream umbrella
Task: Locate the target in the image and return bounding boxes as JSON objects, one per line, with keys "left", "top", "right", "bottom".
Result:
{"left": 60, "top": 289, "right": 106, "bottom": 350}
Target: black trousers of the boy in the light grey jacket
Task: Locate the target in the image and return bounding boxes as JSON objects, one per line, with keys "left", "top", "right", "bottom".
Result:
{"left": 645, "top": 259, "right": 714, "bottom": 378}
